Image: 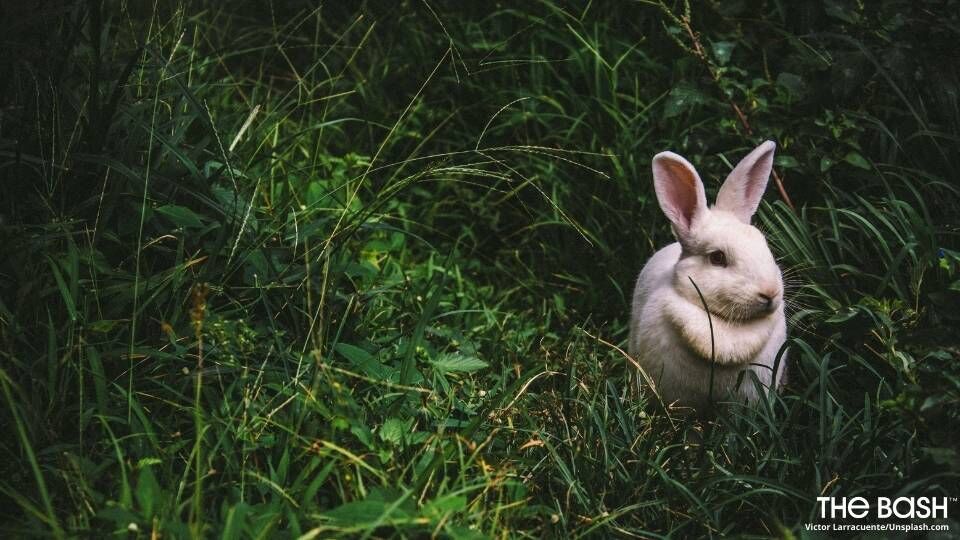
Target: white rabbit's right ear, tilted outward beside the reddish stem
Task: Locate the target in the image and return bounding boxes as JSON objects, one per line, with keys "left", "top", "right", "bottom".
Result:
{"left": 716, "top": 141, "right": 777, "bottom": 224}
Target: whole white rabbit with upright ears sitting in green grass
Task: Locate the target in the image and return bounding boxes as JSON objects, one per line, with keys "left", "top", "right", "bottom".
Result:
{"left": 629, "top": 141, "right": 787, "bottom": 413}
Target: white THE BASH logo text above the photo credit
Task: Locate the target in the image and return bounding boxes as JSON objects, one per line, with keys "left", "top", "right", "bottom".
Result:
{"left": 817, "top": 497, "right": 948, "bottom": 519}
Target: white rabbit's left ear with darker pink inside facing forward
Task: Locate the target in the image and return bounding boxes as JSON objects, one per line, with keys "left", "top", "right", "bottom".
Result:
{"left": 653, "top": 152, "right": 707, "bottom": 238}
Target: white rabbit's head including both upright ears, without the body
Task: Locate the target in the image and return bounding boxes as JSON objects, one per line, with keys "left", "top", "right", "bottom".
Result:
{"left": 653, "top": 141, "right": 783, "bottom": 323}
